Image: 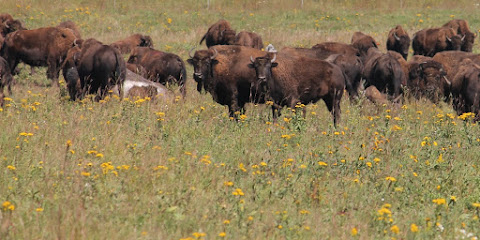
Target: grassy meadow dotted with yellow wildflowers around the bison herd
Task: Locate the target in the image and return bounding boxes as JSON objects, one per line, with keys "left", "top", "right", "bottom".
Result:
{"left": 0, "top": 0, "right": 480, "bottom": 239}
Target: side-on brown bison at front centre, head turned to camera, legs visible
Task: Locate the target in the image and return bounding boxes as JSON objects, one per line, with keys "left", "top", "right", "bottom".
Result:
{"left": 248, "top": 53, "right": 345, "bottom": 126}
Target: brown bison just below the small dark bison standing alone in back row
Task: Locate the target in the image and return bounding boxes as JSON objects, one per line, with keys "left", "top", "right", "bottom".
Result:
{"left": 363, "top": 48, "right": 406, "bottom": 102}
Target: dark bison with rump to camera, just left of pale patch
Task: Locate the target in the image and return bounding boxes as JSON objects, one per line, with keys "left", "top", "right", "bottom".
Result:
{"left": 64, "top": 38, "right": 126, "bottom": 101}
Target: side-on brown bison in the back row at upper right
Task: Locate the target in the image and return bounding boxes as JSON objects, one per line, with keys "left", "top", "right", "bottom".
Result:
{"left": 412, "top": 27, "right": 464, "bottom": 57}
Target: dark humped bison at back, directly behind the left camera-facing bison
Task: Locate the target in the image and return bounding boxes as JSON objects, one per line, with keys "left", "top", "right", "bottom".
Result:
{"left": 200, "top": 19, "right": 236, "bottom": 47}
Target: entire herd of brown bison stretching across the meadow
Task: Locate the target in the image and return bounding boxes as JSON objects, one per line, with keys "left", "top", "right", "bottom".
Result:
{"left": 0, "top": 14, "right": 480, "bottom": 125}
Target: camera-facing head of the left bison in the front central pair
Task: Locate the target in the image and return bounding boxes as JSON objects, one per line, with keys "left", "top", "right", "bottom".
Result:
{"left": 187, "top": 48, "right": 218, "bottom": 92}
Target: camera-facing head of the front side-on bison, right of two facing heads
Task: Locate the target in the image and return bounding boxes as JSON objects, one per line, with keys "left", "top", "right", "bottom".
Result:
{"left": 248, "top": 54, "right": 278, "bottom": 92}
